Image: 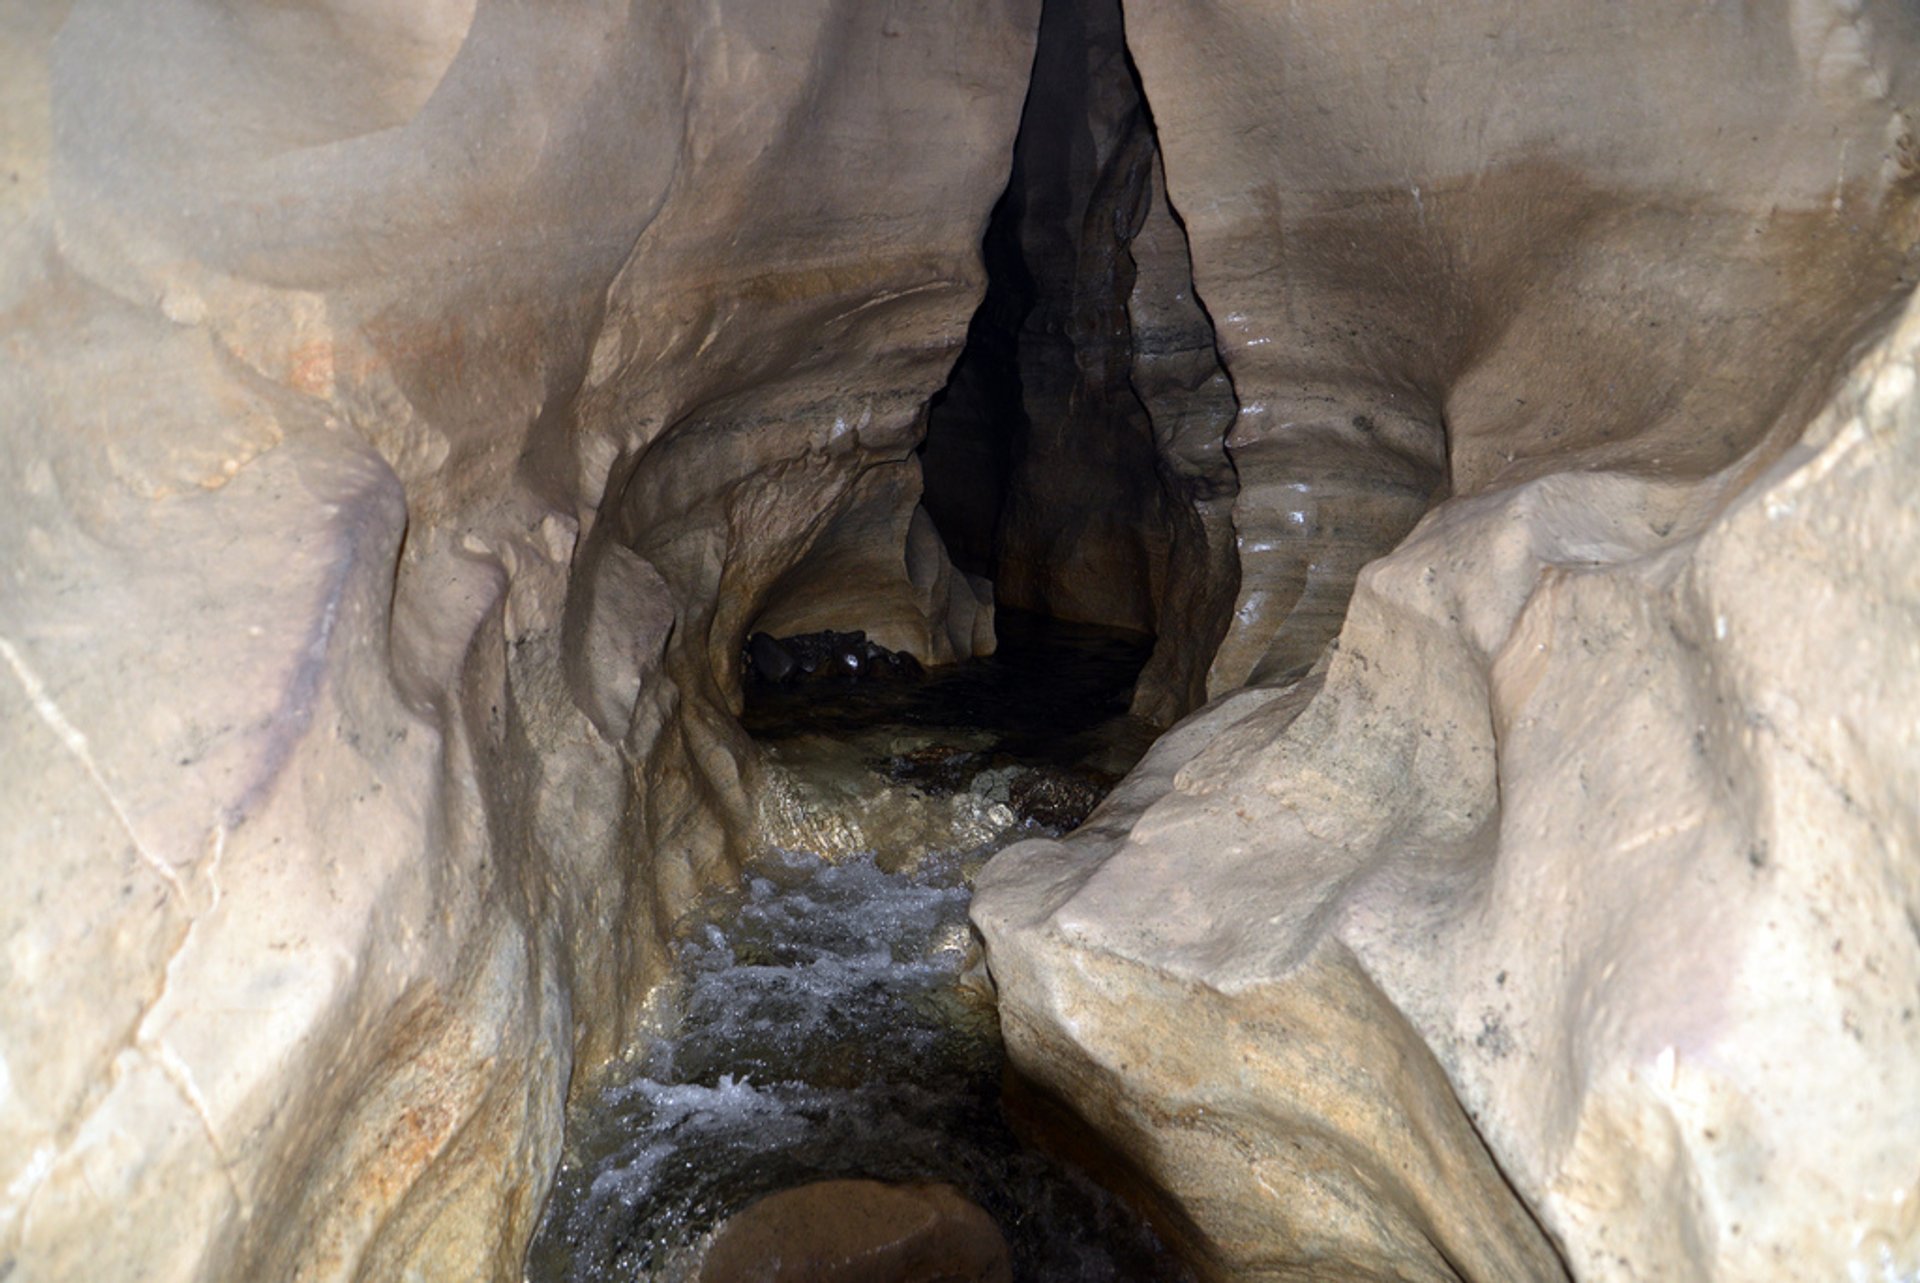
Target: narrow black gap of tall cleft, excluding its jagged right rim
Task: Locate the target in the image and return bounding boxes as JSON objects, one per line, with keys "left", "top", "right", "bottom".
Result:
{"left": 920, "top": 2, "right": 1177, "bottom": 634}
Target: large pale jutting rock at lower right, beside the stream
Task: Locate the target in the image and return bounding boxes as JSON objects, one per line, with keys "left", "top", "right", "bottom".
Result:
{"left": 973, "top": 213, "right": 1920, "bottom": 1281}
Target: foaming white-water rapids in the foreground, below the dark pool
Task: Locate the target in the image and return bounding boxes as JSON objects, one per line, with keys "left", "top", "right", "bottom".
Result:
{"left": 528, "top": 853, "right": 1179, "bottom": 1283}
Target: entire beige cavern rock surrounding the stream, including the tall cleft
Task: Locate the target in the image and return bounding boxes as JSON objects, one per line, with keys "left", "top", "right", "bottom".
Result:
{"left": 0, "top": 0, "right": 1920, "bottom": 1281}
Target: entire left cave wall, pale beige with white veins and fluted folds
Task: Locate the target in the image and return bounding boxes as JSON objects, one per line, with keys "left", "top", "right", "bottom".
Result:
{"left": 0, "top": 0, "right": 1037, "bottom": 1279}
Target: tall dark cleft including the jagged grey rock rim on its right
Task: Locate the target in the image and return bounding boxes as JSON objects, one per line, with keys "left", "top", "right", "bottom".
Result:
{"left": 920, "top": 0, "right": 1238, "bottom": 724}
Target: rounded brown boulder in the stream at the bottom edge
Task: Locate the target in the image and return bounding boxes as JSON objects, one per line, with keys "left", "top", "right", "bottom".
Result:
{"left": 699, "top": 1181, "right": 1014, "bottom": 1283}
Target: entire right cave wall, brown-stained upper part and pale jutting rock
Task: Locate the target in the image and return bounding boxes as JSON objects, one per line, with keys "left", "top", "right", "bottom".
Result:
{"left": 973, "top": 2, "right": 1920, "bottom": 1281}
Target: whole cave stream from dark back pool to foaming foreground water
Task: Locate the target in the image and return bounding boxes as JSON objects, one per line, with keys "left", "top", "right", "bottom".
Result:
{"left": 526, "top": 613, "right": 1187, "bottom": 1283}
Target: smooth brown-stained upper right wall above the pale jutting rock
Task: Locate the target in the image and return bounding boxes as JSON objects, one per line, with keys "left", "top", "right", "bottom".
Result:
{"left": 1127, "top": 0, "right": 1920, "bottom": 695}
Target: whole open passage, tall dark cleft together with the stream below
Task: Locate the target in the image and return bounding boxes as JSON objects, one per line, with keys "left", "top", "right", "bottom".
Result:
{"left": 528, "top": 0, "right": 1213, "bottom": 1283}
